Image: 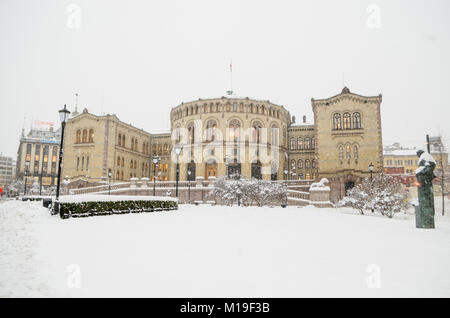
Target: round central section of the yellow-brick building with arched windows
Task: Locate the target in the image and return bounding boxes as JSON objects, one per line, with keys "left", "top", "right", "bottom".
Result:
{"left": 170, "top": 96, "right": 291, "bottom": 180}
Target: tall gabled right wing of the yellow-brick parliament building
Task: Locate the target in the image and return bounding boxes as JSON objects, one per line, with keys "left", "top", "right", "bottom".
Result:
{"left": 312, "top": 88, "right": 383, "bottom": 202}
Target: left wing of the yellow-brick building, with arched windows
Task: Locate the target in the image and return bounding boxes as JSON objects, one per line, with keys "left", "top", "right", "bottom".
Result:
{"left": 62, "top": 109, "right": 150, "bottom": 182}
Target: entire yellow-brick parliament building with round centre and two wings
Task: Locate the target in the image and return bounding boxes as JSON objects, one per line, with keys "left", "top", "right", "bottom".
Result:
{"left": 59, "top": 88, "right": 383, "bottom": 201}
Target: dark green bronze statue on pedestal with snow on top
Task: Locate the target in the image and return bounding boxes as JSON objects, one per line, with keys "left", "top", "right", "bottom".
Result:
{"left": 416, "top": 150, "right": 436, "bottom": 229}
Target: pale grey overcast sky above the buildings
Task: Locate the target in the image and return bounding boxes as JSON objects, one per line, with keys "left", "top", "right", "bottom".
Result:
{"left": 0, "top": 0, "right": 450, "bottom": 156}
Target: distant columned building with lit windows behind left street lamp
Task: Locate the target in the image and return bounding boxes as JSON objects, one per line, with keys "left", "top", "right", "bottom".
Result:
{"left": 16, "top": 127, "right": 61, "bottom": 187}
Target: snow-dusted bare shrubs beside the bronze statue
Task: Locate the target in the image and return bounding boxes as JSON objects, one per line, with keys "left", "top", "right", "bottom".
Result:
{"left": 338, "top": 174, "right": 409, "bottom": 218}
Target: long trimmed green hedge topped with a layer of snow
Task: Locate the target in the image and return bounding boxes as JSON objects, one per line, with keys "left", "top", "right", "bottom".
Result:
{"left": 59, "top": 195, "right": 178, "bottom": 218}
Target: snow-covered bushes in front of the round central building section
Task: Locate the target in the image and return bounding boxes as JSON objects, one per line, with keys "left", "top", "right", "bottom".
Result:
{"left": 211, "top": 175, "right": 287, "bottom": 206}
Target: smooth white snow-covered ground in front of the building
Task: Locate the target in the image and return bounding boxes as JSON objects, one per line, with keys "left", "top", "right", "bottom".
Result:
{"left": 0, "top": 201, "right": 450, "bottom": 297}
